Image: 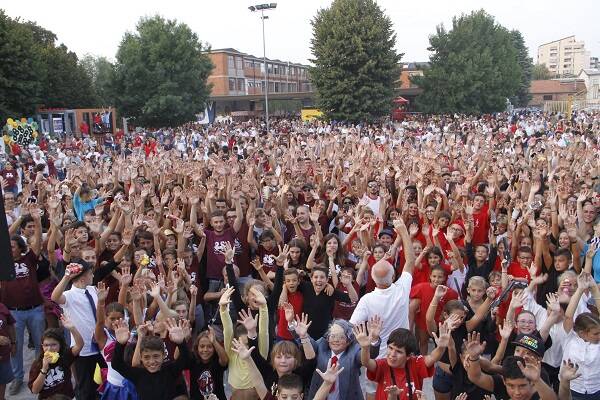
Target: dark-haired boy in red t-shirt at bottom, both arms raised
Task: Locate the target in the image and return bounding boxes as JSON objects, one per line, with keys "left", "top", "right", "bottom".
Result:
{"left": 356, "top": 324, "right": 451, "bottom": 400}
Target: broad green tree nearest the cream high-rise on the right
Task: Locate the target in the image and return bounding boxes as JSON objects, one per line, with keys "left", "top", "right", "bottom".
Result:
{"left": 413, "top": 10, "right": 522, "bottom": 114}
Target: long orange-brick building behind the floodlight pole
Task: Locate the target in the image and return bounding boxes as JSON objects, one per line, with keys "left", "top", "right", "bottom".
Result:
{"left": 208, "top": 48, "right": 313, "bottom": 97}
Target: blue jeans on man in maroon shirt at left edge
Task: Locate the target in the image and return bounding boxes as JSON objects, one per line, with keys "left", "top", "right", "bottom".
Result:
{"left": 10, "top": 305, "right": 46, "bottom": 381}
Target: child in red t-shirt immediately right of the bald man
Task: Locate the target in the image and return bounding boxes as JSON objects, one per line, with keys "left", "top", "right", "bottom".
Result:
{"left": 410, "top": 266, "right": 458, "bottom": 354}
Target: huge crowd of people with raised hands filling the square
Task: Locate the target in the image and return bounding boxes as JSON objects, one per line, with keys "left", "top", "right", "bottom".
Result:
{"left": 0, "top": 112, "right": 600, "bottom": 400}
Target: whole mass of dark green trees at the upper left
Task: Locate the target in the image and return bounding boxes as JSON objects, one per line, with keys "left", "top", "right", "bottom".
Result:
{"left": 0, "top": 10, "right": 96, "bottom": 125}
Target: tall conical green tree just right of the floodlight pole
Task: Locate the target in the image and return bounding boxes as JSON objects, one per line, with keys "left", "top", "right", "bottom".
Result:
{"left": 309, "top": 0, "right": 402, "bottom": 122}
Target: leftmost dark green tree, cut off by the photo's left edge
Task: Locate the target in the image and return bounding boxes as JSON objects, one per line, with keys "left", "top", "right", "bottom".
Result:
{"left": 0, "top": 10, "right": 41, "bottom": 122}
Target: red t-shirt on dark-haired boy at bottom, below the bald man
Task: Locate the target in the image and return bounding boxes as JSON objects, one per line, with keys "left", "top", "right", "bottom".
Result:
{"left": 367, "top": 356, "right": 433, "bottom": 400}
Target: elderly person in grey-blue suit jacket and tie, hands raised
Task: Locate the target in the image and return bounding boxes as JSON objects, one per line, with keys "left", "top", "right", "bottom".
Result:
{"left": 306, "top": 316, "right": 382, "bottom": 400}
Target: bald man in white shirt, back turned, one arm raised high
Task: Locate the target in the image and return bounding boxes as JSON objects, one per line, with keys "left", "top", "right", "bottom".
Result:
{"left": 350, "top": 220, "right": 415, "bottom": 358}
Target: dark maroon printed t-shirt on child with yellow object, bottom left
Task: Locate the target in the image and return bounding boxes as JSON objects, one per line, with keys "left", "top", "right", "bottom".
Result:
{"left": 29, "top": 349, "right": 75, "bottom": 399}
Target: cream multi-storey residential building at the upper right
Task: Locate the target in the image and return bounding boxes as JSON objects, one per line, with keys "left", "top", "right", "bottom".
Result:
{"left": 537, "top": 36, "right": 590, "bottom": 76}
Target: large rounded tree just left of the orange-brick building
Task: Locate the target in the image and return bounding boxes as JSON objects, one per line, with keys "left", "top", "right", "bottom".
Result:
{"left": 114, "top": 16, "right": 213, "bottom": 127}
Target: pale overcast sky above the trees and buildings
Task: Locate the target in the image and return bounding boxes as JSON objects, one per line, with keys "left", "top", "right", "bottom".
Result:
{"left": 0, "top": 0, "right": 600, "bottom": 62}
